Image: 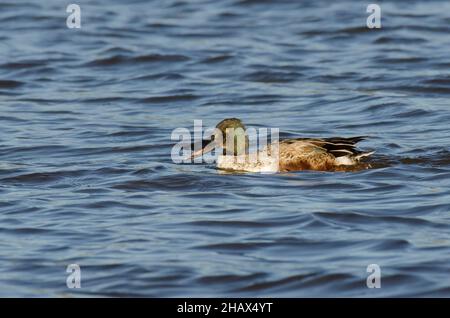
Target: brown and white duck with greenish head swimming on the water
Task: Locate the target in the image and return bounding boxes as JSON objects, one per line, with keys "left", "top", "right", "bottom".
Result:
{"left": 192, "top": 118, "right": 374, "bottom": 172}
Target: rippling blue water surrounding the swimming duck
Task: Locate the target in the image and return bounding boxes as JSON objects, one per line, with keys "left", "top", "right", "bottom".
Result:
{"left": 0, "top": 0, "right": 450, "bottom": 297}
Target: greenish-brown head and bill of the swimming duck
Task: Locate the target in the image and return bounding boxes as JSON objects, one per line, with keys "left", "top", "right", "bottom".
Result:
{"left": 191, "top": 118, "right": 249, "bottom": 158}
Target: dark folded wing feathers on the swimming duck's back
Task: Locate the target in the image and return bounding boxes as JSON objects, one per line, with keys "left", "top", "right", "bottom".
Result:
{"left": 280, "top": 136, "right": 367, "bottom": 158}
